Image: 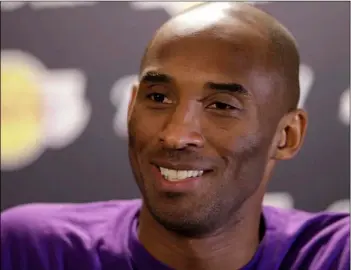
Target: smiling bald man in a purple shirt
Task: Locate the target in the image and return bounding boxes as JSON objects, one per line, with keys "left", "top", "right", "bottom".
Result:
{"left": 1, "top": 3, "right": 350, "bottom": 270}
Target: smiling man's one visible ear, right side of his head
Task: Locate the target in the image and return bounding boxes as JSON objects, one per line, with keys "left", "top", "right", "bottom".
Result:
{"left": 272, "top": 109, "right": 308, "bottom": 160}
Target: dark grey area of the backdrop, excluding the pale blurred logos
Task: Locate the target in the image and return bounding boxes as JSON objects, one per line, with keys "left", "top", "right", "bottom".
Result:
{"left": 1, "top": 2, "right": 350, "bottom": 211}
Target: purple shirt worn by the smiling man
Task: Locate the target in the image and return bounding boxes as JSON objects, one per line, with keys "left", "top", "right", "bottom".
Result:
{"left": 1, "top": 200, "right": 350, "bottom": 270}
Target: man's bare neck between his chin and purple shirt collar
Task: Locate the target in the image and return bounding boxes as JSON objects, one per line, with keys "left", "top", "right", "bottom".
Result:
{"left": 138, "top": 199, "right": 261, "bottom": 270}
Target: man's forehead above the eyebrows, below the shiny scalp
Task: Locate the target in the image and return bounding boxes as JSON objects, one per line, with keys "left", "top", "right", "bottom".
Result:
{"left": 141, "top": 27, "right": 276, "bottom": 99}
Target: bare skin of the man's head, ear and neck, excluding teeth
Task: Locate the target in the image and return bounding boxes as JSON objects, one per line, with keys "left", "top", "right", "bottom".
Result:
{"left": 128, "top": 3, "right": 307, "bottom": 270}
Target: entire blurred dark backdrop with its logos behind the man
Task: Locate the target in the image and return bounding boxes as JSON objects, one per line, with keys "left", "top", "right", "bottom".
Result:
{"left": 1, "top": 1, "right": 350, "bottom": 212}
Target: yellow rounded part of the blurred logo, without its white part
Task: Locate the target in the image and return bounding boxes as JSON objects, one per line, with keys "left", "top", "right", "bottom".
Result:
{"left": 1, "top": 57, "right": 43, "bottom": 167}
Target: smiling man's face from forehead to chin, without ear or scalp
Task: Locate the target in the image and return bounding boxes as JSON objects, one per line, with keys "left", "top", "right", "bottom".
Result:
{"left": 129, "top": 27, "right": 279, "bottom": 234}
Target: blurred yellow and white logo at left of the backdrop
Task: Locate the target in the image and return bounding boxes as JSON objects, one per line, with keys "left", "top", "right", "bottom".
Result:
{"left": 1, "top": 51, "right": 90, "bottom": 170}
